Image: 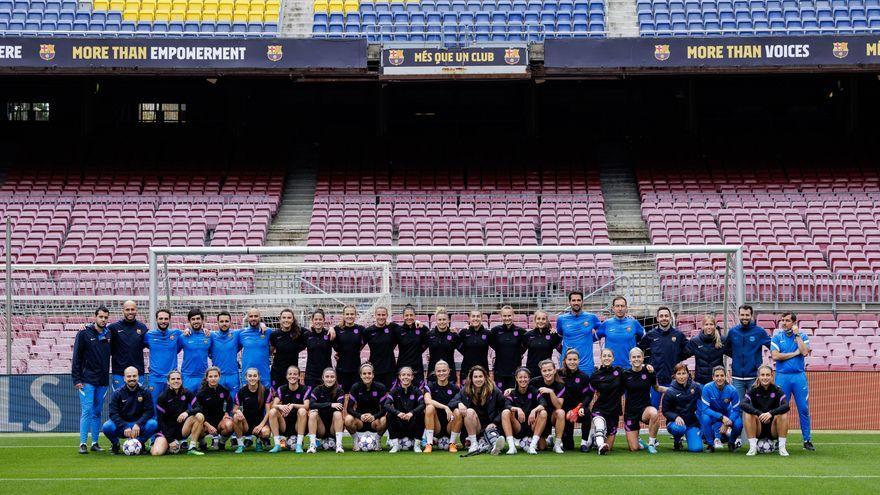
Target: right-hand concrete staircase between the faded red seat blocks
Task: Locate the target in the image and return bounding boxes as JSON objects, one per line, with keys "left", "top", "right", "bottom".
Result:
{"left": 599, "top": 164, "right": 660, "bottom": 311}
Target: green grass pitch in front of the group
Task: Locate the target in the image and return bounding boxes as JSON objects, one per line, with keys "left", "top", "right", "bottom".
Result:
{"left": 0, "top": 433, "right": 880, "bottom": 495}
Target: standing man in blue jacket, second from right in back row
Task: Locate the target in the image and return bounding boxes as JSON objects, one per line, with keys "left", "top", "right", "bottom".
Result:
{"left": 724, "top": 305, "right": 770, "bottom": 401}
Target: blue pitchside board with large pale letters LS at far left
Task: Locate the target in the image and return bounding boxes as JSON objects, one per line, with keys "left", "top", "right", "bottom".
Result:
{"left": 0, "top": 375, "right": 109, "bottom": 433}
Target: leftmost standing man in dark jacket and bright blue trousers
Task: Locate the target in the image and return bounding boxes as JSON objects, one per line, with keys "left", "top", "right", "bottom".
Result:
{"left": 70, "top": 306, "right": 110, "bottom": 454}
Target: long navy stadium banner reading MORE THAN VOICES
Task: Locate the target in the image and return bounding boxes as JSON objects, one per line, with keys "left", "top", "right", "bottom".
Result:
{"left": 544, "top": 36, "right": 880, "bottom": 70}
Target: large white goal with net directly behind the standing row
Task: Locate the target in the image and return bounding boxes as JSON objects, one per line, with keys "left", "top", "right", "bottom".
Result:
{"left": 148, "top": 245, "right": 745, "bottom": 332}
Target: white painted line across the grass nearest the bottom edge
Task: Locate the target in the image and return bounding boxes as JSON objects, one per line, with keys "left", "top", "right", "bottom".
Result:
{"left": 0, "top": 473, "right": 880, "bottom": 482}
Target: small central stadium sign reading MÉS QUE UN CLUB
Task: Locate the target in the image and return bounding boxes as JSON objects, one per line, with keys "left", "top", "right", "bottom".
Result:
{"left": 382, "top": 46, "right": 529, "bottom": 76}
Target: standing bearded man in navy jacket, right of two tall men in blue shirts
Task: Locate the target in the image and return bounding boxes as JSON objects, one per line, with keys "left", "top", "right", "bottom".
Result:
{"left": 640, "top": 306, "right": 688, "bottom": 409}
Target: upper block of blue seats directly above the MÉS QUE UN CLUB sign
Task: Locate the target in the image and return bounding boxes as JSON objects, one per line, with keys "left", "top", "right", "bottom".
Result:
{"left": 312, "top": 0, "right": 605, "bottom": 45}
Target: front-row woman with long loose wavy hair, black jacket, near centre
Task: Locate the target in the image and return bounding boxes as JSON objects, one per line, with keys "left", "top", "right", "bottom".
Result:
{"left": 453, "top": 365, "right": 507, "bottom": 455}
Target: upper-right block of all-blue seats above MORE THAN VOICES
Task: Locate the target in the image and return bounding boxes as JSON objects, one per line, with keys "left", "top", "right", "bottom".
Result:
{"left": 635, "top": 0, "right": 880, "bottom": 36}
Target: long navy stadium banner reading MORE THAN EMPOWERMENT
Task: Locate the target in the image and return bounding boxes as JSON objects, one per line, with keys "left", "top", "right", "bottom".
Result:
{"left": 0, "top": 38, "right": 367, "bottom": 70}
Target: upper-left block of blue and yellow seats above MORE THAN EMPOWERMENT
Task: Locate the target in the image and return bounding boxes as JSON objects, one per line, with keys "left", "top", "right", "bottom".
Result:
{"left": 0, "top": 0, "right": 281, "bottom": 37}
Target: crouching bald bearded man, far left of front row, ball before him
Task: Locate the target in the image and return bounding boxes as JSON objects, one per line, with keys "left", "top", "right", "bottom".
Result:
{"left": 102, "top": 366, "right": 159, "bottom": 454}
